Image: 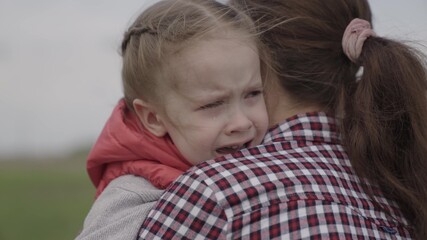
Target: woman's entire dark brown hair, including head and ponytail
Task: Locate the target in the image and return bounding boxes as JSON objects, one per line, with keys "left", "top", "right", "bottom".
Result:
{"left": 230, "top": 0, "right": 427, "bottom": 239}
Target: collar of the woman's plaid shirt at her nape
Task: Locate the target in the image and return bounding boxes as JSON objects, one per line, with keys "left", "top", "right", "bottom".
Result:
{"left": 264, "top": 112, "right": 340, "bottom": 144}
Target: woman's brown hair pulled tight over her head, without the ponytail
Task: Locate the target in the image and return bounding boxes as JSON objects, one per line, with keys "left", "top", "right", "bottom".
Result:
{"left": 231, "top": 0, "right": 371, "bottom": 110}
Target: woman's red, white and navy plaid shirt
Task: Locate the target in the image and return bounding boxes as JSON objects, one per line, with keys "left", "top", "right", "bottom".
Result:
{"left": 139, "top": 113, "right": 411, "bottom": 240}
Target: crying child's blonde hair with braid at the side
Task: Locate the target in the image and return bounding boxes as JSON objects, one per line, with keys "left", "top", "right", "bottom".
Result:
{"left": 121, "top": 0, "right": 267, "bottom": 109}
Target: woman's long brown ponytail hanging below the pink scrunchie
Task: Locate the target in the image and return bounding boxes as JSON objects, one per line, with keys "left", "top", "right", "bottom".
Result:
{"left": 341, "top": 36, "right": 427, "bottom": 239}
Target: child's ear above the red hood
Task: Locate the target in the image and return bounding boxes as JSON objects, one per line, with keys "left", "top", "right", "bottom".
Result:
{"left": 133, "top": 99, "right": 167, "bottom": 137}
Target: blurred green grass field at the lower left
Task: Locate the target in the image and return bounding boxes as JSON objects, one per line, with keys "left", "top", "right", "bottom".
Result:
{"left": 0, "top": 151, "right": 95, "bottom": 240}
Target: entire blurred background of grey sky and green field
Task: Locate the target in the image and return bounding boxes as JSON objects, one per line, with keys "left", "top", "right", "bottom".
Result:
{"left": 0, "top": 0, "right": 427, "bottom": 240}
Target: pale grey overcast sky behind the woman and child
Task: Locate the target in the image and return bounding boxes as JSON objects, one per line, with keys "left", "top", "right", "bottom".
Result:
{"left": 0, "top": 0, "right": 427, "bottom": 160}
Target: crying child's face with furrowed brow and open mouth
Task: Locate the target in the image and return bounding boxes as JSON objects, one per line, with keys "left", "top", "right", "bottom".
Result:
{"left": 155, "top": 39, "right": 268, "bottom": 164}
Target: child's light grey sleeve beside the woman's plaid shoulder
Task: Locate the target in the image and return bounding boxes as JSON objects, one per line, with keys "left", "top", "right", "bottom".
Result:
{"left": 76, "top": 175, "right": 163, "bottom": 240}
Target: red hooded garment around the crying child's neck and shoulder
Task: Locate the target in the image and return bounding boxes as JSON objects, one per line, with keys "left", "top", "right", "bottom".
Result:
{"left": 87, "top": 99, "right": 192, "bottom": 197}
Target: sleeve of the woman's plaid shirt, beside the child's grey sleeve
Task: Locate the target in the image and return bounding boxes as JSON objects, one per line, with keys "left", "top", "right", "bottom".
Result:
{"left": 139, "top": 175, "right": 227, "bottom": 240}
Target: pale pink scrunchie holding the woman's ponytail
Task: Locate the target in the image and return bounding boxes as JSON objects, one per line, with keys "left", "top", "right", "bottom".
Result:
{"left": 342, "top": 18, "right": 376, "bottom": 62}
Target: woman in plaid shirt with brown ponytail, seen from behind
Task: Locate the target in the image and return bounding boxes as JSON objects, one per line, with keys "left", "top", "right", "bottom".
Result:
{"left": 140, "top": 0, "right": 427, "bottom": 239}
